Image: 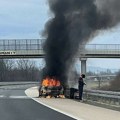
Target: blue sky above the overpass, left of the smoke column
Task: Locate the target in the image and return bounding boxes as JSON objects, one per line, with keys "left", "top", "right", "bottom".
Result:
{"left": 0, "top": 0, "right": 48, "bottom": 39}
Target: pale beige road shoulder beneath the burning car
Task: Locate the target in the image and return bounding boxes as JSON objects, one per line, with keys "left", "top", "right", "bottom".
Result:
{"left": 25, "top": 87, "right": 120, "bottom": 120}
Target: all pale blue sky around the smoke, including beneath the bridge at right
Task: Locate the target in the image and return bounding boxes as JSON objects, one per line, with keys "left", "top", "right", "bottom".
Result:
{"left": 0, "top": 0, "right": 120, "bottom": 69}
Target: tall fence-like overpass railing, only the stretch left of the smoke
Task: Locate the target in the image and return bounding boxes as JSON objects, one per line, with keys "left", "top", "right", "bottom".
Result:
{"left": 0, "top": 39, "right": 44, "bottom": 51}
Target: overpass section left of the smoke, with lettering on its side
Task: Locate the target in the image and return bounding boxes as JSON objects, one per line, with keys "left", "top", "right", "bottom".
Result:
{"left": 0, "top": 39, "right": 45, "bottom": 59}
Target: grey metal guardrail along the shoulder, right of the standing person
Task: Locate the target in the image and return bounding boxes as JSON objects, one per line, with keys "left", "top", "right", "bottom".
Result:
{"left": 84, "top": 90, "right": 120, "bottom": 107}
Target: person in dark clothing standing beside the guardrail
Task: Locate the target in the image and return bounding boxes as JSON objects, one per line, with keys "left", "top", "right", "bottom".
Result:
{"left": 78, "top": 74, "right": 86, "bottom": 100}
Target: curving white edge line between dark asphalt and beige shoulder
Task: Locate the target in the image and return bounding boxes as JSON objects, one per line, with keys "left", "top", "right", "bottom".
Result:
{"left": 25, "top": 87, "right": 84, "bottom": 120}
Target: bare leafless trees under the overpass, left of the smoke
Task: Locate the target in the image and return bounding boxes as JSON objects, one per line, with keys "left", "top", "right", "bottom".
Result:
{"left": 0, "top": 59, "right": 41, "bottom": 82}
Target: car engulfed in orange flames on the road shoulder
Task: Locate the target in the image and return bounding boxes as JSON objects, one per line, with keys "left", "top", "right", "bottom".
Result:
{"left": 39, "top": 77, "right": 64, "bottom": 98}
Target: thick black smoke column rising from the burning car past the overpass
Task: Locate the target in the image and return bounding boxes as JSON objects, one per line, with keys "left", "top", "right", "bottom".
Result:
{"left": 44, "top": 0, "right": 120, "bottom": 83}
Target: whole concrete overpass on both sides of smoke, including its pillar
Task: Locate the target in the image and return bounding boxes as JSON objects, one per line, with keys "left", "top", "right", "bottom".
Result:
{"left": 0, "top": 39, "right": 120, "bottom": 73}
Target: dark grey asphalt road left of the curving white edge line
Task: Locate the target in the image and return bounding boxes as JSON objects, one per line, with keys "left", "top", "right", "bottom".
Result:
{"left": 0, "top": 84, "right": 74, "bottom": 120}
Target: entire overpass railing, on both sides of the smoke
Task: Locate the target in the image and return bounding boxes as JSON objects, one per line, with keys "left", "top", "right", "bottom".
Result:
{"left": 0, "top": 39, "right": 120, "bottom": 54}
